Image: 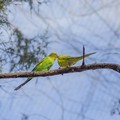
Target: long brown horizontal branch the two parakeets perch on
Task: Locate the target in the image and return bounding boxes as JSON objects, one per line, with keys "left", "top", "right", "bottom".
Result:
{"left": 0, "top": 63, "right": 120, "bottom": 79}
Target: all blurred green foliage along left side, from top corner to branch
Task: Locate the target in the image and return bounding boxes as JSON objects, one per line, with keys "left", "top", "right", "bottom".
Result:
{"left": 0, "top": 0, "right": 48, "bottom": 71}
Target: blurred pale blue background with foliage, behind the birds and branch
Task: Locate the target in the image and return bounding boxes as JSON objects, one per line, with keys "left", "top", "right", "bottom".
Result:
{"left": 0, "top": 0, "right": 120, "bottom": 120}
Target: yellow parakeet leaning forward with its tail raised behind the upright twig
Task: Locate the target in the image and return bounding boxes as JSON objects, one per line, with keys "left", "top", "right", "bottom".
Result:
{"left": 58, "top": 52, "right": 96, "bottom": 68}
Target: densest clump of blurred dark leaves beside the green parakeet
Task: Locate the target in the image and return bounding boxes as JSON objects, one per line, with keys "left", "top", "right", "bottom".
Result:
{"left": 6, "top": 29, "right": 48, "bottom": 71}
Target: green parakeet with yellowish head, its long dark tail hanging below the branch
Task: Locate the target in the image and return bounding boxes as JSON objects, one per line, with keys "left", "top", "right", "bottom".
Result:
{"left": 14, "top": 52, "right": 58, "bottom": 90}
